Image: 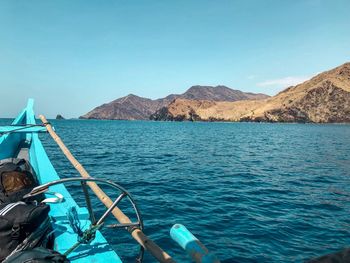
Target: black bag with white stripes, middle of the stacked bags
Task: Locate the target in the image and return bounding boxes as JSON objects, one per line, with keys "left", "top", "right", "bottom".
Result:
{"left": 0, "top": 202, "right": 50, "bottom": 262}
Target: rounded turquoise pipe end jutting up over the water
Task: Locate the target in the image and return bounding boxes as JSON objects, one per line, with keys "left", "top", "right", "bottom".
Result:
{"left": 170, "top": 224, "right": 220, "bottom": 263}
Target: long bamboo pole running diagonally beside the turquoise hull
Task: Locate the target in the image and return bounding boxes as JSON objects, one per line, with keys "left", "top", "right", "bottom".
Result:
{"left": 39, "top": 115, "right": 175, "bottom": 263}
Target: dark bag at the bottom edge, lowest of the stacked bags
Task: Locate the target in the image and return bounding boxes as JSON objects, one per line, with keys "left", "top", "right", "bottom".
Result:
{"left": 3, "top": 247, "right": 70, "bottom": 263}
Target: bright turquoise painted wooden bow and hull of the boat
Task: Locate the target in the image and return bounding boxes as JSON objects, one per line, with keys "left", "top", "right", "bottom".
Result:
{"left": 0, "top": 100, "right": 122, "bottom": 263}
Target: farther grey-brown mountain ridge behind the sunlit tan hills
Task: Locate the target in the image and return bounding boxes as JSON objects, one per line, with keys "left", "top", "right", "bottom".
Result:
{"left": 80, "top": 86, "right": 268, "bottom": 120}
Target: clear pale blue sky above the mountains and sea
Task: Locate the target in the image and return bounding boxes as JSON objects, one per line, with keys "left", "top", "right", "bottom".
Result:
{"left": 0, "top": 0, "right": 350, "bottom": 117}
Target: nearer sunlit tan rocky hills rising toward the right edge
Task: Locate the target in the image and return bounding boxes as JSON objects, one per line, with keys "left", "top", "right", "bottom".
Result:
{"left": 151, "top": 63, "right": 350, "bottom": 123}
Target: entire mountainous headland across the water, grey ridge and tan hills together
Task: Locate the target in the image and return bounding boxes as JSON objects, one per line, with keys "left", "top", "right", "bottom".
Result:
{"left": 80, "top": 63, "right": 350, "bottom": 123}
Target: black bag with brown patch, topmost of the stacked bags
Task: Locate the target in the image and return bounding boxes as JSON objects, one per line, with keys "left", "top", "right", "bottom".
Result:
{"left": 0, "top": 158, "right": 43, "bottom": 204}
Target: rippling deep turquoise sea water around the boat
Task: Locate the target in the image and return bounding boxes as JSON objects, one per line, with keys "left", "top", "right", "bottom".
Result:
{"left": 3, "top": 120, "right": 350, "bottom": 262}
